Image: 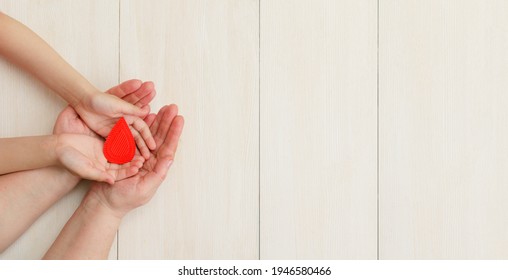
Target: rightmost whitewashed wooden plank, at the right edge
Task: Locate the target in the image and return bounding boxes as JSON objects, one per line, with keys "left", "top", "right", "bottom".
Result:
{"left": 379, "top": 0, "right": 508, "bottom": 259}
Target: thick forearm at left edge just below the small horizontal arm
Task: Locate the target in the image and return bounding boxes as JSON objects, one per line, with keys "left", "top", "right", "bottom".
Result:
{"left": 0, "top": 167, "right": 80, "bottom": 252}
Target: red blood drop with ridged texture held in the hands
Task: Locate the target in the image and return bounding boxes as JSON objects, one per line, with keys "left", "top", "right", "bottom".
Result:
{"left": 103, "top": 118, "right": 136, "bottom": 164}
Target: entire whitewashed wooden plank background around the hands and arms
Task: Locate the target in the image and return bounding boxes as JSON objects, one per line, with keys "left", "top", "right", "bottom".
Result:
{"left": 0, "top": 0, "right": 508, "bottom": 259}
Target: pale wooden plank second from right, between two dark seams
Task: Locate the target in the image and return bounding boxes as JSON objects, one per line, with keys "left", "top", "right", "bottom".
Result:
{"left": 260, "top": 0, "right": 377, "bottom": 259}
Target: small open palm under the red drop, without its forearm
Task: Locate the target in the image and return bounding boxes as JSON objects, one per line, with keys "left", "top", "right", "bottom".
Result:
{"left": 55, "top": 134, "right": 145, "bottom": 184}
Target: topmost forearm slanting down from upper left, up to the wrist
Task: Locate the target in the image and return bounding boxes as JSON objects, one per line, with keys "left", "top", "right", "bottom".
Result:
{"left": 0, "top": 12, "right": 98, "bottom": 106}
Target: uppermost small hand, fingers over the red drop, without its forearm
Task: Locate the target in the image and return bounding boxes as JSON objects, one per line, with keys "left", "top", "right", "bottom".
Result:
{"left": 74, "top": 84, "right": 156, "bottom": 159}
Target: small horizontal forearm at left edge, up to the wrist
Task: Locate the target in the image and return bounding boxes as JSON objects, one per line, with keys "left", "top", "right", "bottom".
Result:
{"left": 0, "top": 135, "right": 58, "bottom": 174}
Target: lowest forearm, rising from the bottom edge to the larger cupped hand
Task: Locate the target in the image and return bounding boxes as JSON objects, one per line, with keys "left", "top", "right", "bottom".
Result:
{"left": 44, "top": 192, "right": 122, "bottom": 259}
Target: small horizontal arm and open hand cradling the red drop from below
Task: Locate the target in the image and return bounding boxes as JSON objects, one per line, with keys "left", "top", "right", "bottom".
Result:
{"left": 0, "top": 111, "right": 144, "bottom": 184}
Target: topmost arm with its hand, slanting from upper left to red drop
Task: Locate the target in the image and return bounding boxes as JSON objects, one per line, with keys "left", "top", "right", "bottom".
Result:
{"left": 0, "top": 12, "right": 155, "bottom": 158}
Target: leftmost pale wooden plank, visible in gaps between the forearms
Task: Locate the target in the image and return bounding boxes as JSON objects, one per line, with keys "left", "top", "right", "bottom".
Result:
{"left": 0, "top": 0, "right": 118, "bottom": 259}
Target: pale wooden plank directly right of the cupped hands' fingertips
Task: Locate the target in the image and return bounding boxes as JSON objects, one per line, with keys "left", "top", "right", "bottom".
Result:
{"left": 119, "top": 0, "right": 259, "bottom": 259}
